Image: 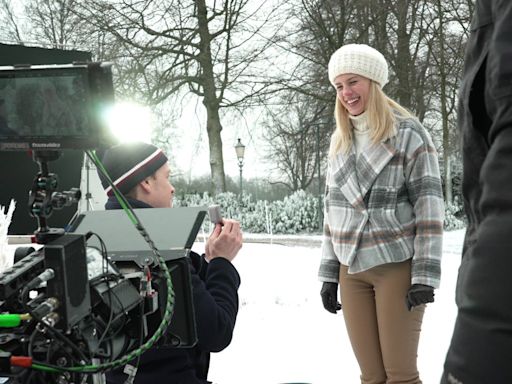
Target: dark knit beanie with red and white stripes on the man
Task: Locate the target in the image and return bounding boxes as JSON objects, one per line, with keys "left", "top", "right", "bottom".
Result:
{"left": 99, "top": 142, "right": 167, "bottom": 196}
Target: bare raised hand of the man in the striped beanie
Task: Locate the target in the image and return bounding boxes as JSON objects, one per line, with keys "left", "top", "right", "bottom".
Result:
{"left": 205, "top": 219, "right": 242, "bottom": 261}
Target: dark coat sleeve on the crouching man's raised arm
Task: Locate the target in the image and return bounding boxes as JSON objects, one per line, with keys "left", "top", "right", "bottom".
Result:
{"left": 192, "top": 255, "right": 240, "bottom": 352}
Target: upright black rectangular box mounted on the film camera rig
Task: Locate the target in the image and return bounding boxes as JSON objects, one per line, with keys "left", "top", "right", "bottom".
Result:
{"left": 43, "top": 234, "right": 91, "bottom": 330}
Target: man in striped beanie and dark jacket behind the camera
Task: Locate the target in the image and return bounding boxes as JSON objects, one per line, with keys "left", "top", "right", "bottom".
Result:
{"left": 100, "top": 143, "right": 246, "bottom": 384}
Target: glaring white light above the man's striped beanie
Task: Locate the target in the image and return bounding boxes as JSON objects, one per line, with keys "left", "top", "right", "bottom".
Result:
{"left": 105, "top": 101, "right": 152, "bottom": 143}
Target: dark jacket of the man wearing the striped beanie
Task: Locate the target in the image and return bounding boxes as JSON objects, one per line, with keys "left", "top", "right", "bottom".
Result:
{"left": 105, "top": 197, "right": 240, "bottom": 384}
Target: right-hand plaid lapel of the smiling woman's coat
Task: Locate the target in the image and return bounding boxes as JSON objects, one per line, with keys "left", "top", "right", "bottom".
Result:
{"left": 356, "top": 140, "right": 397, "bottom": 196}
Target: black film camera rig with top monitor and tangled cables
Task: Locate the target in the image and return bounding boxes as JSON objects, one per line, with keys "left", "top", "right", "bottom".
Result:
{"left": 0, "top": 63, "right": 200, "bottom": 384}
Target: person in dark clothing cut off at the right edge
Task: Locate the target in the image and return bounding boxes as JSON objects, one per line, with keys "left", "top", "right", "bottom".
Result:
{"left": 442, "top": 0, "right": 512, "bottom": 384}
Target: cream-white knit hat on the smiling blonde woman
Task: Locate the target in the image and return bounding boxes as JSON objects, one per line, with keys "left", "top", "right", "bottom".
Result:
{"left": 329, "top": 44, "right": 388, "bottom": 87}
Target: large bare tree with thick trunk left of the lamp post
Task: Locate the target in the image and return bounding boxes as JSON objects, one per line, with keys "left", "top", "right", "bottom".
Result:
{"left": 68, "top": 0, "right": 280, "bottom": 192}
